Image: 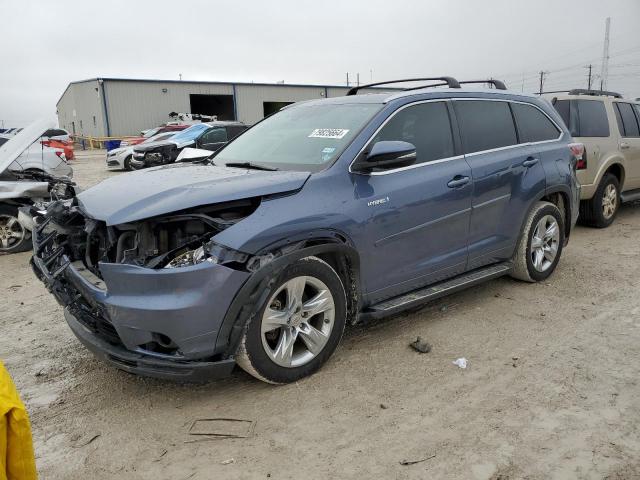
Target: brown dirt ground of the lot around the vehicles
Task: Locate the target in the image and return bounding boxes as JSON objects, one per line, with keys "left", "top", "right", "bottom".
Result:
{"left": 0, "top": 154, "right": 640, "bottom": 480}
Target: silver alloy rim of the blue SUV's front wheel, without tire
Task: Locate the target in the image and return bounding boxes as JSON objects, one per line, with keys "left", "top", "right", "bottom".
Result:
{"left": 261, "top": 276, "right": 335, "bottom": 368}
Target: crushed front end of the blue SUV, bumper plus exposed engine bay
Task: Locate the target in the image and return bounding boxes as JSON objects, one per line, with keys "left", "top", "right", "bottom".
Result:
{"left": 31, "top": 199, "right": 259, "bottom": 381}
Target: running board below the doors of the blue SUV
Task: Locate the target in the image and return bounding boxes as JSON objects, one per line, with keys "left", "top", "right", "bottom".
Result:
{"left": 360, "top": 262, "right": 512, "bottom": 321}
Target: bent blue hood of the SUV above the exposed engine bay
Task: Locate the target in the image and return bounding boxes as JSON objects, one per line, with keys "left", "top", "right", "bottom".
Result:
{"left": 77, "top": 164, "right": 310, "bottom": 225}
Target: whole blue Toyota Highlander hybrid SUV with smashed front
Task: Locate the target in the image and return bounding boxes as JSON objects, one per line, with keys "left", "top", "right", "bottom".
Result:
{"left": 32, "top": 77, "right": 584, "bottom": 383}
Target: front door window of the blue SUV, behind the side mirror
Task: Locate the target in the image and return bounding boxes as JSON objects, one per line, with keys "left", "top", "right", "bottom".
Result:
{"left": 371, "top": 102, "right": 454, "bottom": 163}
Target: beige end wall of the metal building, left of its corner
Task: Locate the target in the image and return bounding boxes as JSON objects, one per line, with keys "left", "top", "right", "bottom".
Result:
{"left": 57, "top": 80, "right": 106, "bottom": 137}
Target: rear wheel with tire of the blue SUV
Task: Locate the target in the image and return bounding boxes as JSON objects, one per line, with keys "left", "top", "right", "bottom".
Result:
{"left": 511, "top": 202, "right": 564, "bottom": 282}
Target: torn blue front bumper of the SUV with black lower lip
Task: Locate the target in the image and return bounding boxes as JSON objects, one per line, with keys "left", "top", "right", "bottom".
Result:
{"left": 31, "top": 223, "right": 249, "bottom": 381}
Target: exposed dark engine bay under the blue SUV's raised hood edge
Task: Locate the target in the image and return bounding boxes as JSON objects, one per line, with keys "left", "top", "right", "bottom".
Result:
{"left": 38, "top": 198, "right": 260, "bottom": 277}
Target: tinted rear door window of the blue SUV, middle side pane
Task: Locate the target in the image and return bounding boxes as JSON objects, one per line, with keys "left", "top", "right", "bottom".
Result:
{"left": 454, "top": 100, "right": 518, "bottom": 153}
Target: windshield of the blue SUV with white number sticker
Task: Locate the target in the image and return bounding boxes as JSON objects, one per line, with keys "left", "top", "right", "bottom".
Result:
{"left": 214, "top": 103, "right": 382, "bottom": 172}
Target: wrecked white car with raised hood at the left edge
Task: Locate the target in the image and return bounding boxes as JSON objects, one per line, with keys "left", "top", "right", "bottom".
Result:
{"left": 0, "top": 121, "right": 76, "bottom": 254}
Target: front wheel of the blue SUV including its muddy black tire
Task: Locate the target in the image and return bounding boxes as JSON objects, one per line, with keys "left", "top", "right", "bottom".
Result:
{"left": 236, "top": 257, "right": 347, "bottom": 384}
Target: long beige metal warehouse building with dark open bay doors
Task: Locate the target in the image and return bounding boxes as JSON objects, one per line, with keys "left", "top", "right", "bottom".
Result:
{"left": 56, "top": 78, "right": 379, "bottom": 137}
